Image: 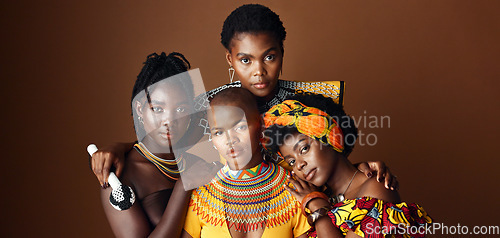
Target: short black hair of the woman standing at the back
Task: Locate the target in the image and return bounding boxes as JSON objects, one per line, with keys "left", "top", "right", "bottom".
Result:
{"left": 220, "top": 4, "right": 286, "bottom": 51}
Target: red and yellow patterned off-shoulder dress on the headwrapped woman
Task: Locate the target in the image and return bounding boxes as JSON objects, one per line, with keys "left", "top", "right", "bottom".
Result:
{"left": 308, "top": 197, "right": 432, "bottom": 238}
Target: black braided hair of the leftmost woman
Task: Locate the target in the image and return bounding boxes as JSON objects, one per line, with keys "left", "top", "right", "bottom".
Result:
{"left": 131, "top": 52, "right": 194, "bottom": 138}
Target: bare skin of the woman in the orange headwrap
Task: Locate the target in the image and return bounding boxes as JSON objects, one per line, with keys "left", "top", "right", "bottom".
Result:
{"left": 280, "top": 133, "right": 400, "bottom": 237}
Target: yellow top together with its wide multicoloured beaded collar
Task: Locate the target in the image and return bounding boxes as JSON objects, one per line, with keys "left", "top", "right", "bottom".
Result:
{"left": 184, "top": 162, "right": 310, "bottom": 238}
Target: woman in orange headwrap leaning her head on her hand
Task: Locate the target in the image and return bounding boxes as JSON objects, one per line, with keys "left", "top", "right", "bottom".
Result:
{"left": 264, "top": 95, "right": 432, "bottom": 237}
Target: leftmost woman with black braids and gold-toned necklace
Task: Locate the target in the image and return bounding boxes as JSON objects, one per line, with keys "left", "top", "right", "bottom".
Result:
{"left": 101, "top": 52, "right": 215, "bottom": 237}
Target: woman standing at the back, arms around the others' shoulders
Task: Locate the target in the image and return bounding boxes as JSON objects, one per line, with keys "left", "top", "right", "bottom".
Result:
{"left": 92, "top": 4, "right": 397, "bottom": 192}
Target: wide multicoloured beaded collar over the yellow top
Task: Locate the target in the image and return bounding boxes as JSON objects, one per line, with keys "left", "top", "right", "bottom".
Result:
{"left": 189, "top": 162, "right": 300, "bottom": 232}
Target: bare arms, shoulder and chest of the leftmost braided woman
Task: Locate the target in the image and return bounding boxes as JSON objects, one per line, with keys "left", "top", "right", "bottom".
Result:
{"left": 101, "top": 150, "right": 218, "bottom": 237}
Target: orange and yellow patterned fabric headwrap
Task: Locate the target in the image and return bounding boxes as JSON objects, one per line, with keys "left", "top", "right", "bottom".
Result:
{"left": 263, "top": 100, "right": 344, "bottom": 153}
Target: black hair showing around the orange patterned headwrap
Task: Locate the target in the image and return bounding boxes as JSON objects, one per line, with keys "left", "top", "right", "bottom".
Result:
{"left": 264, "top": 93, "right": 358, "bottom": 157}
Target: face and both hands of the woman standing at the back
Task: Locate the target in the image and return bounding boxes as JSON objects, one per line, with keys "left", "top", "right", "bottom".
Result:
{"left": 91, "top": 32, "right": 398, "bottom": 190}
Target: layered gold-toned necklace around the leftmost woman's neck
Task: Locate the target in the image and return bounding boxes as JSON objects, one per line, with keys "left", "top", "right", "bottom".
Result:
{"left": 134, "top": 142, "right": 186, "bottom": 181}
